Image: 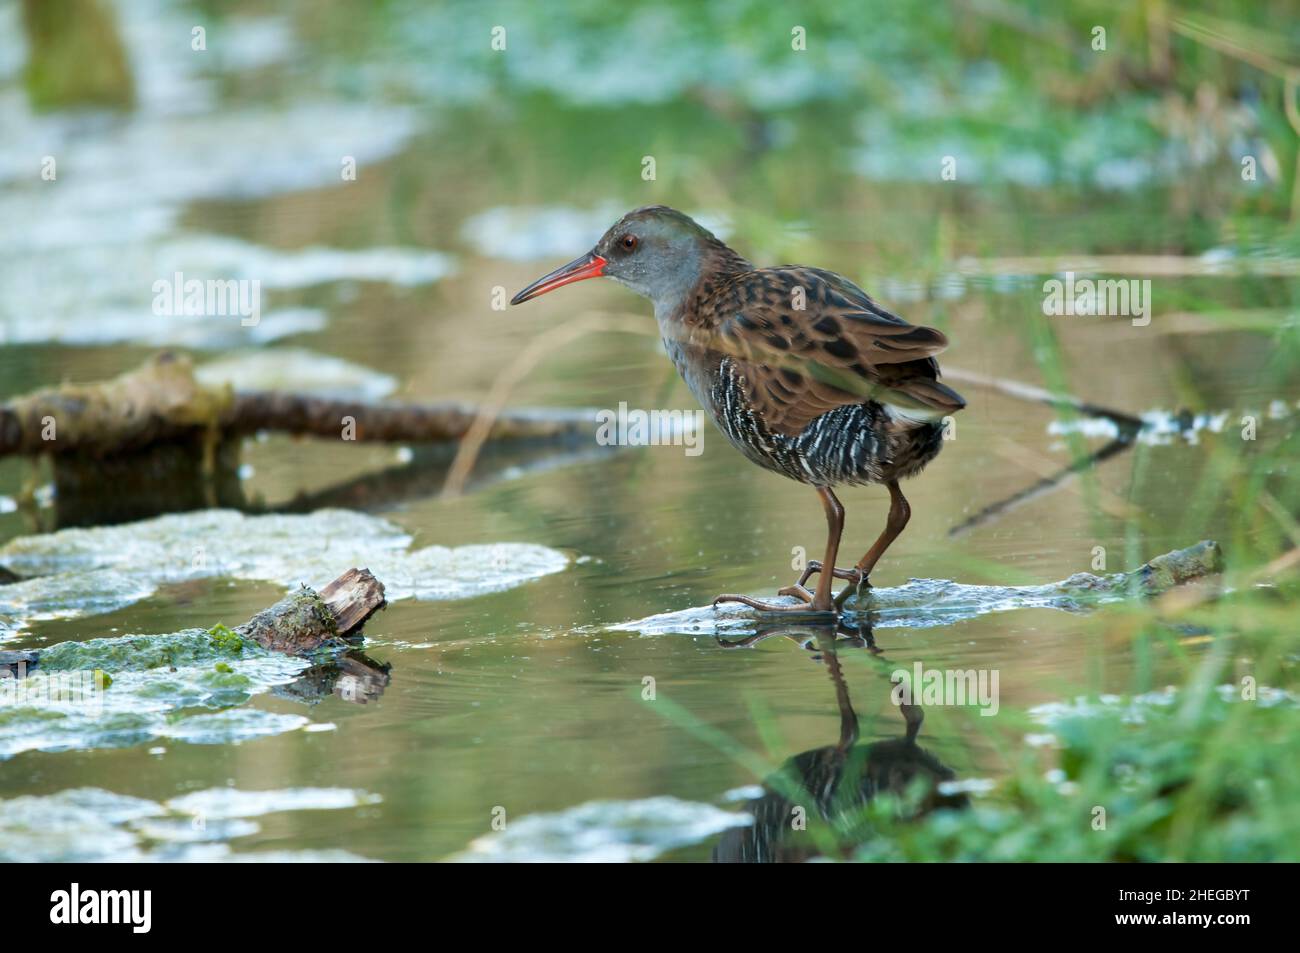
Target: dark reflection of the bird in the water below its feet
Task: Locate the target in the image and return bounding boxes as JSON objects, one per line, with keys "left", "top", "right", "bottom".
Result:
{"left": 712, "top": 623, "right": 967, "bottom": 863}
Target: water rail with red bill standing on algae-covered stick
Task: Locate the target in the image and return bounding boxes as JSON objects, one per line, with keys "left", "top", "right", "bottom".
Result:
{"left": 511, "top": 205, "right": 966, "bottom": 616}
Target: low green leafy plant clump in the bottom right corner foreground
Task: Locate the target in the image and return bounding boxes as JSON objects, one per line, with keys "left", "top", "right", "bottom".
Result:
{"left": 854, "top": 688, "right": 1300, "bottom": 862}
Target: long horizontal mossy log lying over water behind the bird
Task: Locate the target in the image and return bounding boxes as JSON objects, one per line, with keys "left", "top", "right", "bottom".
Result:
{"left": 0, "top": 352, "right": 595, "bottom": 459}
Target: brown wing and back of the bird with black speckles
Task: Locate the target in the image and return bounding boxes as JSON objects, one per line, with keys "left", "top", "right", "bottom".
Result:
{"left": 701, "top": 267, "right": 965, "bottom": 436}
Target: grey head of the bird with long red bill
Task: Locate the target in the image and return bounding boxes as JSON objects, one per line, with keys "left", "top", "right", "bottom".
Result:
{"left": 510, "top": 205, "right": 738, "bottom": 311}
